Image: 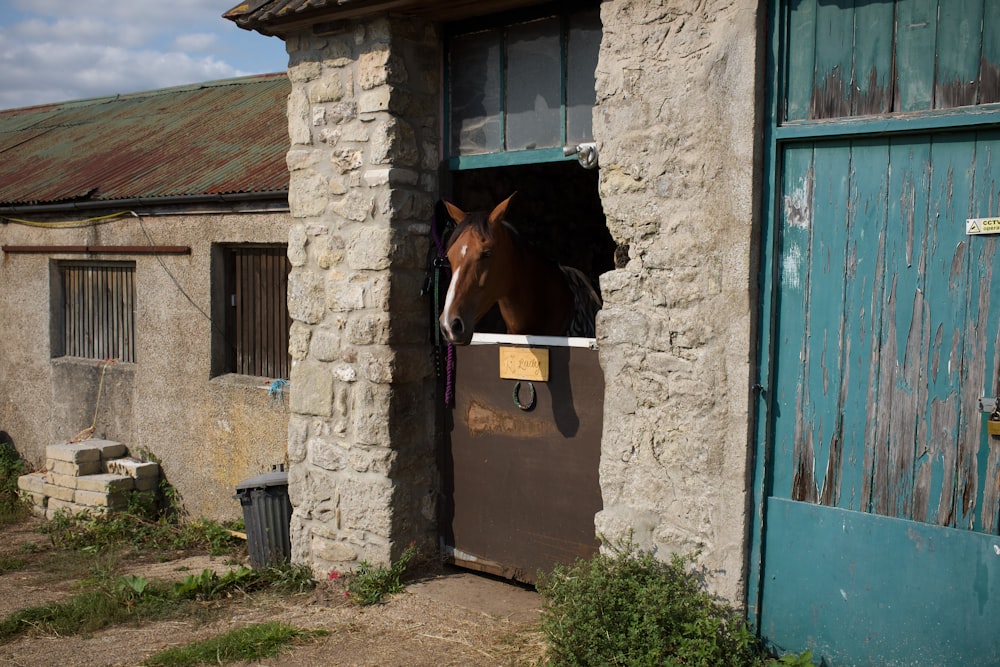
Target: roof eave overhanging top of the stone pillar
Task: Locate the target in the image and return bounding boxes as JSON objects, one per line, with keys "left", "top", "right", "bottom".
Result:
{"left": 222, "top": 0, "right": 544, "bottom": 35}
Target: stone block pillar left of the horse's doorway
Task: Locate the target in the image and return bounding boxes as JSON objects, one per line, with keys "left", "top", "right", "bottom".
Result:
{"left": 286, "top": 16, "right": 440, "bottom": 572}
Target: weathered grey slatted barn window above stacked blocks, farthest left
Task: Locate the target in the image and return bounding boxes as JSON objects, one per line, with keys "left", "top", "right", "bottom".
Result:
{"left": 52, "top": 262, "right": 135, "bottom": 362}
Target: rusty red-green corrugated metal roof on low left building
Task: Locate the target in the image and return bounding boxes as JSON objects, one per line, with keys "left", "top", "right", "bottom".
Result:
{"left": 0, "top": 73, "right": 291, "bottom": 206}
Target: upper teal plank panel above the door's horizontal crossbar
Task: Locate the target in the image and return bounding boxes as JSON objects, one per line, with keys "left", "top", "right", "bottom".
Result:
{"left": 773, "top": 0, "right": 1000, "bottom": 121}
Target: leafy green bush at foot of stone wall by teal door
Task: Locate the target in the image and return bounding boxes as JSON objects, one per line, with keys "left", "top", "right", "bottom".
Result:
{"left": 538, "top": 544, "right": 764, "bottom": 666}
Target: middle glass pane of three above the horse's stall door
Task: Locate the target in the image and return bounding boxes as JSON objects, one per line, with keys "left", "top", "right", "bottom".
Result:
{"left": 506, "top": 18, "right": 562, "bottom": 150}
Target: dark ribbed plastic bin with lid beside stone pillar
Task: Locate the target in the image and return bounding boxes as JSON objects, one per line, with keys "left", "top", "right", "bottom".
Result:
{"left": 233, "top": 471, "right": 292, "bottom": 567}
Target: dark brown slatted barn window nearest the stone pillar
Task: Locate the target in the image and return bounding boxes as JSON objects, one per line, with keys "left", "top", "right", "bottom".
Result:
{"left": 212, "top": 245, "right": 291, "bottom": 378}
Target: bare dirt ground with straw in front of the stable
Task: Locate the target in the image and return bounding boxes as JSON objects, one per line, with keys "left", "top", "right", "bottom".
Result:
{"left": 0, "top": 520, "right": 544, "bottom": 667}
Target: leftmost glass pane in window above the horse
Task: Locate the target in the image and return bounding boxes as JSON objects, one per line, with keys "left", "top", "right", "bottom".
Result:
{"left": 450, "top": 30, "right": 502, "bottom": 156}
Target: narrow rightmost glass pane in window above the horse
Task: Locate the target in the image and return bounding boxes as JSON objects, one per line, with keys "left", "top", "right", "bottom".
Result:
{"left": 566, "top": 10, "right": 601, "bottom": 144}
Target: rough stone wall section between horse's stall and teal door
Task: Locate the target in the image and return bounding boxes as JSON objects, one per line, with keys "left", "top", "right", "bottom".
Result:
{"left": 594, "top": 0, "right": 762, "bottom": 599}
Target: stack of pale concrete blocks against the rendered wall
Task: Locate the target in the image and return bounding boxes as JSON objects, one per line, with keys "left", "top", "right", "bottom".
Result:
{"left": 17, "top": 440, "right": 160, "bottom": 519}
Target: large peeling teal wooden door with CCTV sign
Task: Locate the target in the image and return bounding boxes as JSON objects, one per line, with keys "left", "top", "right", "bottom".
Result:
{"left": 750, "top": 0, "right": 1000, "bottom": 665}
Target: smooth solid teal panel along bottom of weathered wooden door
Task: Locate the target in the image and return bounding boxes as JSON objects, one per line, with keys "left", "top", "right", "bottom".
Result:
{"left": 760, "top": 499, "right": 1000, "bottom": 667}
